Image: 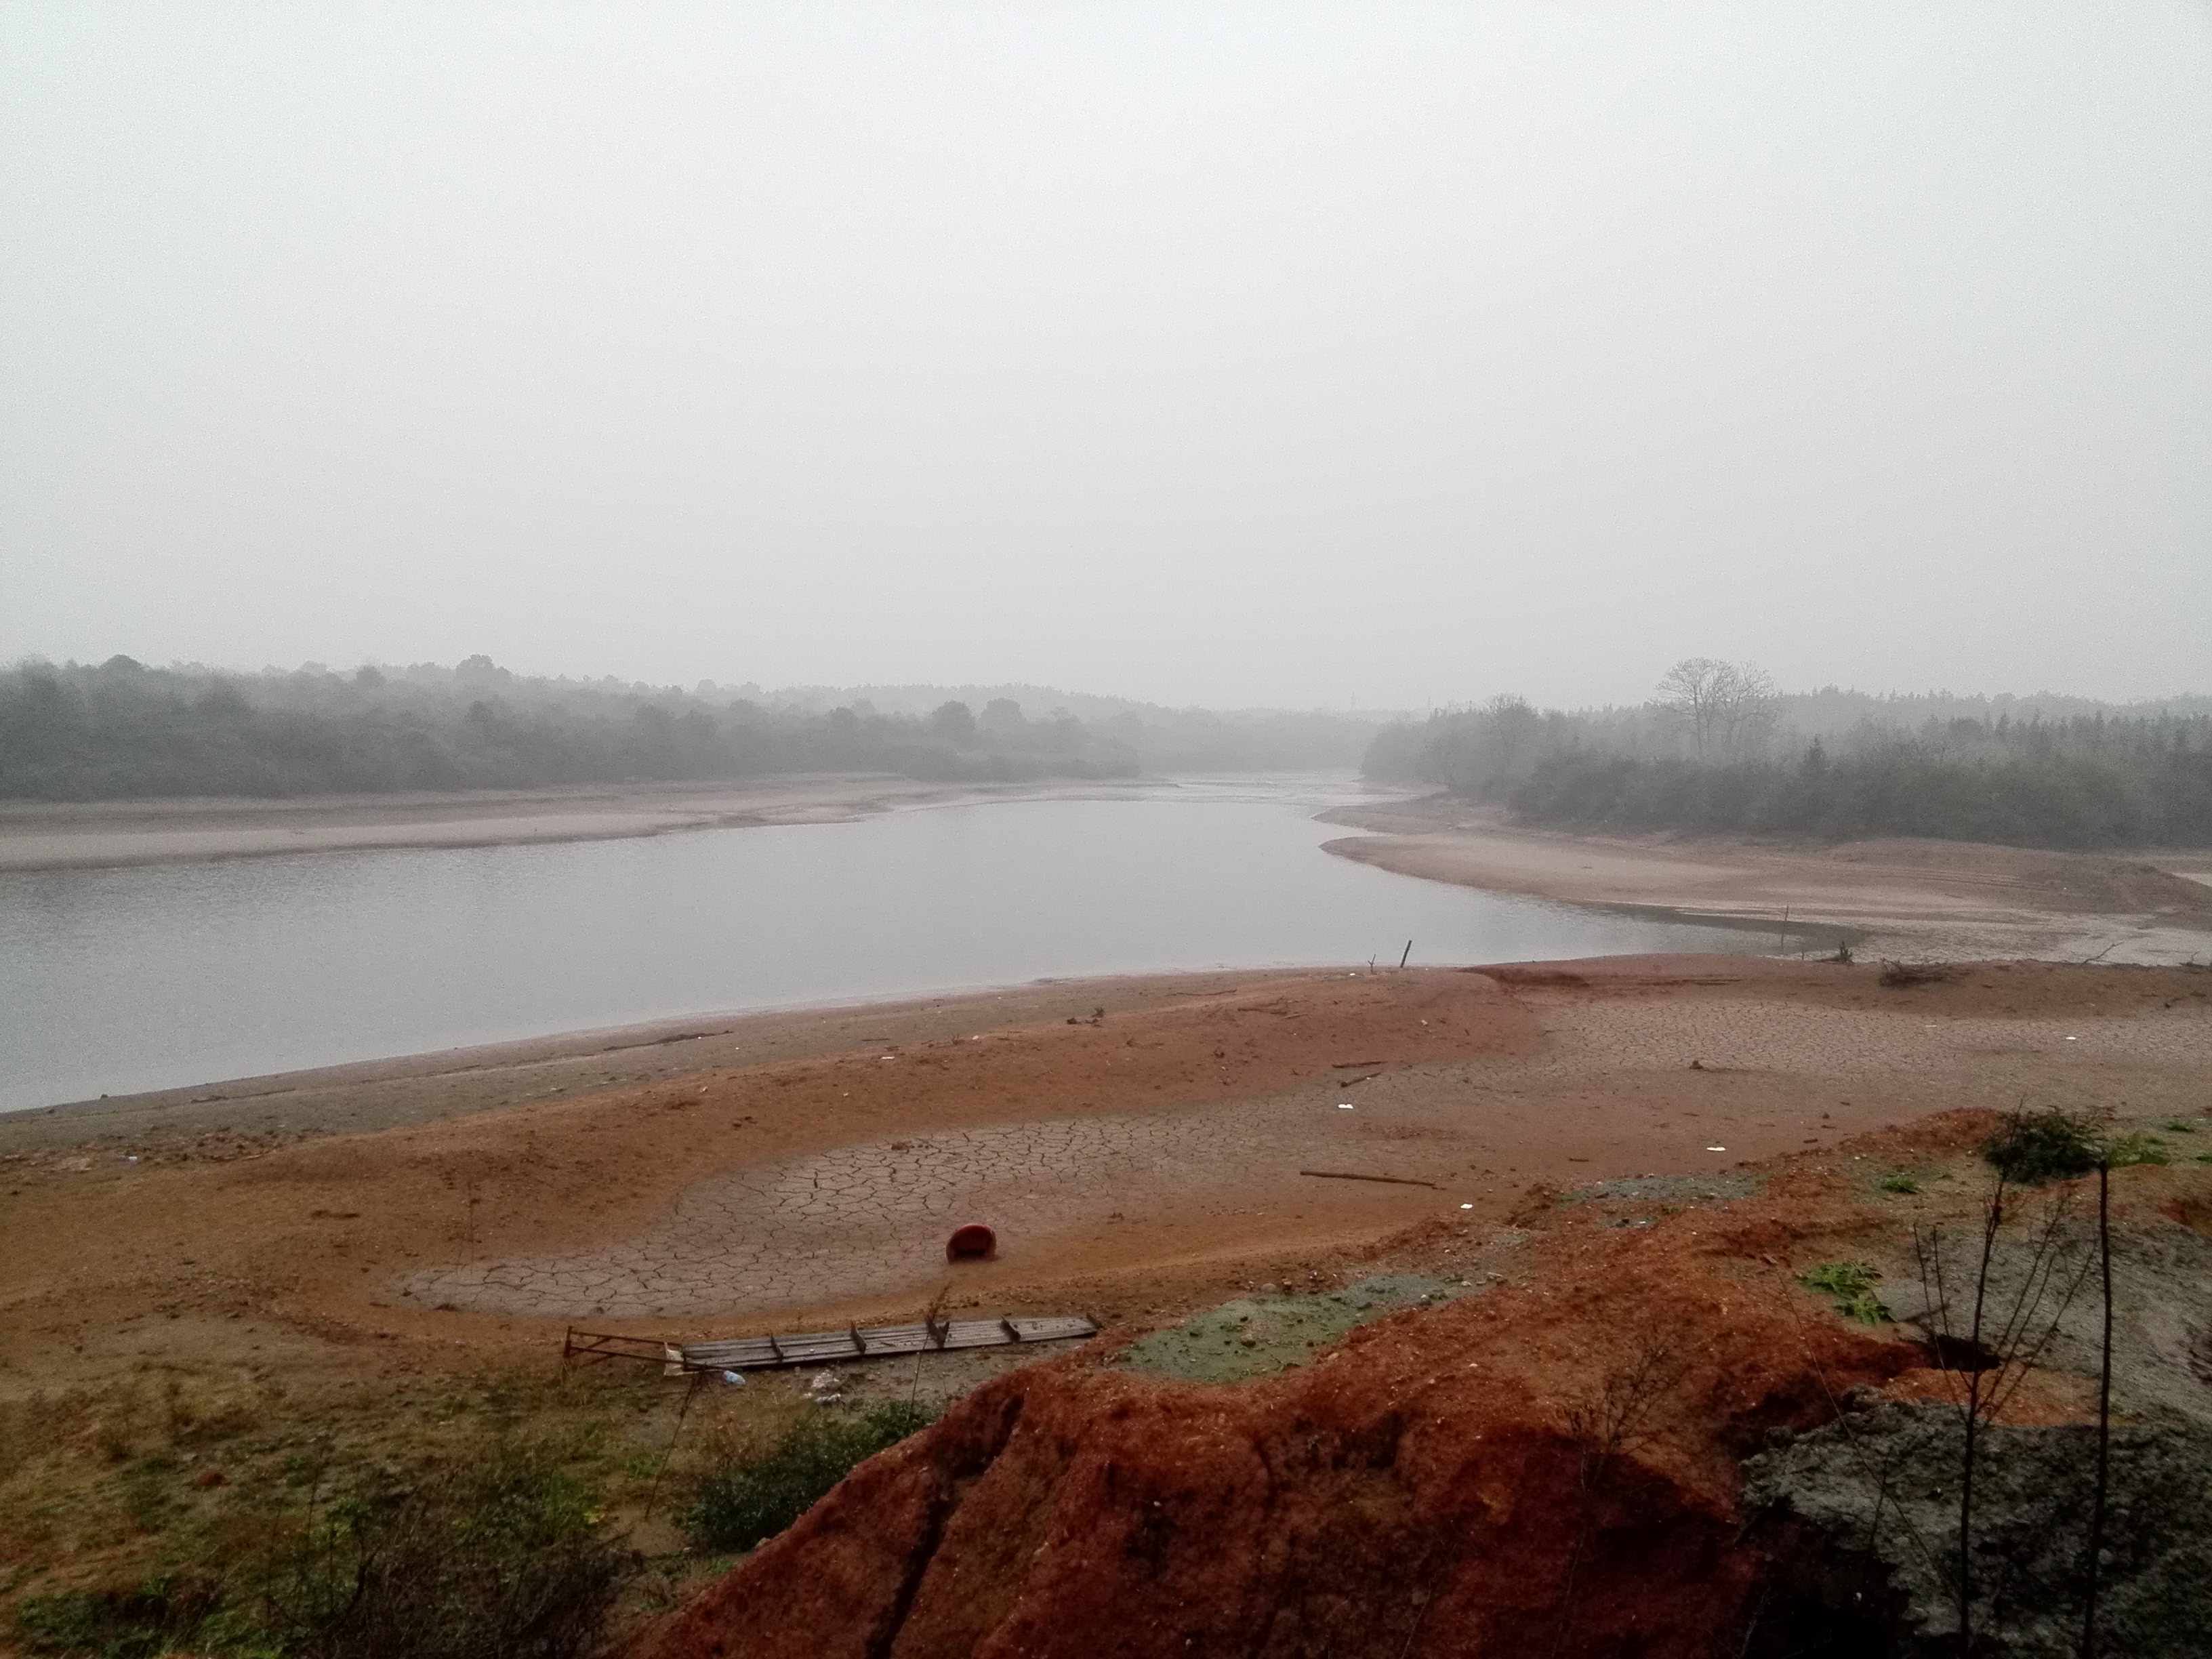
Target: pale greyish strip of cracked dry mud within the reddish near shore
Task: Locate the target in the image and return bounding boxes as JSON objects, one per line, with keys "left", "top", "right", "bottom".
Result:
{"left": 405, "top": 1004, "right": 2212, "bottom": 1318}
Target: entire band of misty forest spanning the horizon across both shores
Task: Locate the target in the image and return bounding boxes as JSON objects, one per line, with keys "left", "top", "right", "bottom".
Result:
{"left": 0, "top": 657, "right": 2212, "bottom": 849}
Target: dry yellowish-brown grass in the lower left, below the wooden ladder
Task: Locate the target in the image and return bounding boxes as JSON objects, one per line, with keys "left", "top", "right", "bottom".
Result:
{"left": 0, "top": 1363, "right": 810, "bottom": 1650}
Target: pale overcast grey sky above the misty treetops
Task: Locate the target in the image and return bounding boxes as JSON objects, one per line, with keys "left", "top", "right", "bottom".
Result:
{"left": 0, "top": 0, "right": 2212, "bottom": 705}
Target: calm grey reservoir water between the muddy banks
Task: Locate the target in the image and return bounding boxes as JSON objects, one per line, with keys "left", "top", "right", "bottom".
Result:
{"left": 0, "top": 785, "right": 1759, "bottom": 1111}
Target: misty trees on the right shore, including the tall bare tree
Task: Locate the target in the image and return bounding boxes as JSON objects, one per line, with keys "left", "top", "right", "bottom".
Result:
{"left": 1365, "top": 659, "right": 2212, "bottom": 849}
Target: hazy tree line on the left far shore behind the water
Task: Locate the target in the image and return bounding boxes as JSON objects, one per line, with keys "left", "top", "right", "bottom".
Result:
{"left": 0, "top": 657, "right": 1374, "bottom": 801}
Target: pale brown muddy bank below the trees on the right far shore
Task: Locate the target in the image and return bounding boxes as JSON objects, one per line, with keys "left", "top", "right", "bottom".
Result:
{"left": 1323, "top": 796, "right": 2212, "bottom": 962}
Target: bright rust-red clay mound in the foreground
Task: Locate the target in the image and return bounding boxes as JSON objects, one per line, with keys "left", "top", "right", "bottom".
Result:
{"left": 628, "top": 1113, "right": 2026, "bottom": 1659}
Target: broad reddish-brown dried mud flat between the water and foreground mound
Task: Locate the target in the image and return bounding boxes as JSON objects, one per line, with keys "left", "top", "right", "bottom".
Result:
{"left": 0, "top": 958, "right": 2212, "bottom": 1393}
